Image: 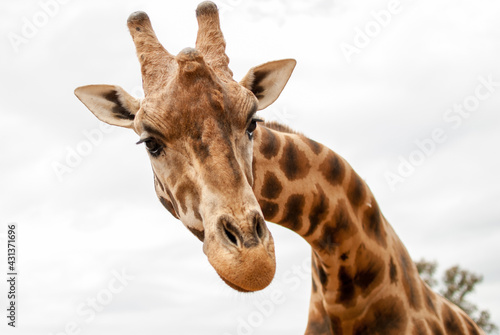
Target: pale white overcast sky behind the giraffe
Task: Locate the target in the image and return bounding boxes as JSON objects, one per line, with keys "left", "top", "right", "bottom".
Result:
{"left": 0, "top": 0, "right": 500, "bottom": 335}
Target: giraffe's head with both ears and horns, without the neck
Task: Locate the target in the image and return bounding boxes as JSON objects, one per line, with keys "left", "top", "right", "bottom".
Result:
{"left": 75, "top": 2, "right": 295, "bottom": 292}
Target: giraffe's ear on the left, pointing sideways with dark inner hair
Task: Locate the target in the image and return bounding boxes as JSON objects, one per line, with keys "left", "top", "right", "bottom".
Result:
{"left": 75, "top": 85, "right": 141, "bottom": 129}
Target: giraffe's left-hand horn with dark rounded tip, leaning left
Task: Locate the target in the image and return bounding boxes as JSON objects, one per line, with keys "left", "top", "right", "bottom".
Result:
{"left": 127, "top": 12, "right": 173, "bottom": 94}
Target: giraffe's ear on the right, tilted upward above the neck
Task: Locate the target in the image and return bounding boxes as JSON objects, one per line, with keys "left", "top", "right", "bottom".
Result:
{"left": 240, "top": 59, "right": 297, "bottom": 110}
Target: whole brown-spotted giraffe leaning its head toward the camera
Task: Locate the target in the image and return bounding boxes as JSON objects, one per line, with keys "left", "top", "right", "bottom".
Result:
{"left": 75, "top": 1, "right": 484, "bottom": 335}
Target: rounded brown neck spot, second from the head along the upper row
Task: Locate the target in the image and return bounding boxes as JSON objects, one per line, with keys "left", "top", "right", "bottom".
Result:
{"left": 279, "top": 139, "right": 311, "bottom": 180}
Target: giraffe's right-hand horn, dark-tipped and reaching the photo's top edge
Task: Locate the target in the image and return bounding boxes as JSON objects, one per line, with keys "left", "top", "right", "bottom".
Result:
{"left": 196, "top": 1, "right": 233, "bottom": 77}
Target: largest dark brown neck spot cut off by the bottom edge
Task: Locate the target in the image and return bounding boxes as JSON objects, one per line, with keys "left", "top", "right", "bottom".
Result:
{"left": 353, "top": 297, "right": 408, "bottom": 335}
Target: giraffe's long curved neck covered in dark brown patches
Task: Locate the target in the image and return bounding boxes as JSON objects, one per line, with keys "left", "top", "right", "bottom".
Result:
{"left": 253, "top": 125, "right": 482, "bottom": 334}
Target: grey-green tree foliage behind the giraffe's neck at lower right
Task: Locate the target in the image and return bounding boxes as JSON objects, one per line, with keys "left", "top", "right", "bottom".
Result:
{"left": 415, "top": 259, "right": 498, "bottom": 334}
